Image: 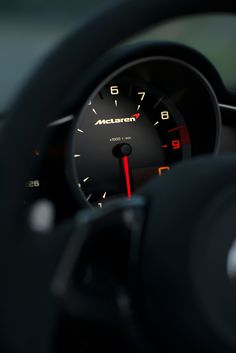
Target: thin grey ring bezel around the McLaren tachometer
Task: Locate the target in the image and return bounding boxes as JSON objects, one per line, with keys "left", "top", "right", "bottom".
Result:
{"left": 66, "top": 42, "right": 222, "bottom": 207}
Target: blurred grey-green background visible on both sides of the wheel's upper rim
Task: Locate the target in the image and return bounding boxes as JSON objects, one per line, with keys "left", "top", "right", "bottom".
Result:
{"left": 0, "top": 0, "right": 236, "bottom": 112}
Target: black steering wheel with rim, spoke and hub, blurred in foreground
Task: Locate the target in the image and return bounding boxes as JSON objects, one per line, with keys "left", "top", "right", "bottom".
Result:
{"left": 0, "top": 0, "right": 236, "bottom": 353}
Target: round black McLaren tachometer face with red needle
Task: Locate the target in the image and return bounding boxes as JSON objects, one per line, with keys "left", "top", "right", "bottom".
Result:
{"left": 71, "top": 78, "right": 191, "bottom": 207}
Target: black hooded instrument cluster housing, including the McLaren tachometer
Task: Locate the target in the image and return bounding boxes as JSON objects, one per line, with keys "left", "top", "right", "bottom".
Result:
{"left": 24, "top": 41, "right": 236, "bottom": 221}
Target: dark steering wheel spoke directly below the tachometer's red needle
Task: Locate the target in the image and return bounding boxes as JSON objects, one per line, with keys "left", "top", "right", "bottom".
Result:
{"left": 52, "top": 197, "right": 145, "bottom": 324}
